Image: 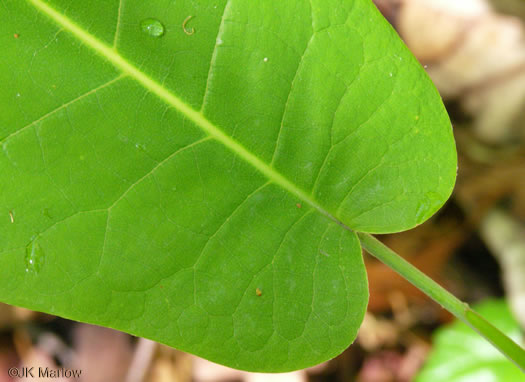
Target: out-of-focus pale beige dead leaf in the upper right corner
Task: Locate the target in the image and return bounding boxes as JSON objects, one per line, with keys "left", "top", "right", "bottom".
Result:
{"left": 398, "top": 0, "right": 525, "bottom": 144}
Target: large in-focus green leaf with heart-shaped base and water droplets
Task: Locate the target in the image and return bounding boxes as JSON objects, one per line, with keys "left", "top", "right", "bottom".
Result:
{"left": 0, "top": 0, "right": 456, "bottom": 371}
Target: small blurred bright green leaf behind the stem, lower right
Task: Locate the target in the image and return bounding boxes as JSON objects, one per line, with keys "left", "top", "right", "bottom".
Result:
{"left": 416, "top": 300, "right": 523, "bottom": 382}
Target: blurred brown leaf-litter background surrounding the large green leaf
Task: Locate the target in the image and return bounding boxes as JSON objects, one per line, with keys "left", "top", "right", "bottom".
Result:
{"left": 0, "top": 0, "right": 525, "bottom": 382}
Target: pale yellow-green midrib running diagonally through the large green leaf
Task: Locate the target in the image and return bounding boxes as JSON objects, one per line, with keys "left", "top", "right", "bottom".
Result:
{"left": 28, "top": 0, "right": 342, "bottom": 225}
